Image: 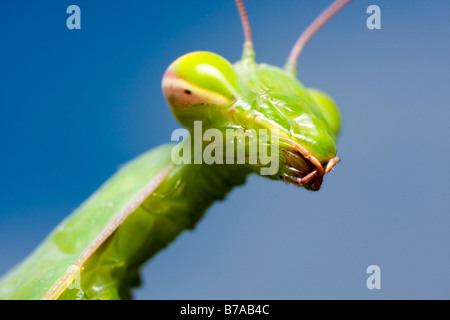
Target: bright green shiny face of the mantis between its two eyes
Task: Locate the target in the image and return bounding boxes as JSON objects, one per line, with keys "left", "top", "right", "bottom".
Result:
{"left": 235, "top": 59, "right": 336, "bottom": 163}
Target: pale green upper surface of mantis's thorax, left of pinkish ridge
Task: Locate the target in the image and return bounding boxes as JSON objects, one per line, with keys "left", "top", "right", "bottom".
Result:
{"left": 0, "top": 146, "right": 174, "bottom": 299}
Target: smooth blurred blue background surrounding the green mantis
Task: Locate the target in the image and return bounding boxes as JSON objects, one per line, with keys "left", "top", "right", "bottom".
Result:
{"left": 0, "top": 0, "right": 450, "bottom": 299}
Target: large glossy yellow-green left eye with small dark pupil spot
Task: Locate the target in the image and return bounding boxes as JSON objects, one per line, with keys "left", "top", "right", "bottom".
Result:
{"left": 162, "top": 51, "right": 239, "bottom": 127}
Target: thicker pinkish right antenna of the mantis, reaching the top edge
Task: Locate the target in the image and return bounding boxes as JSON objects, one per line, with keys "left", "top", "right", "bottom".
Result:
{"left": 286, "top": 0, "right": 351, "bottom": 74}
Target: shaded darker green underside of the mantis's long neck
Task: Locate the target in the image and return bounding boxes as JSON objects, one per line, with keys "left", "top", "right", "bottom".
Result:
{"left": 73, "top": 149, "right": 250, "bottom": 299}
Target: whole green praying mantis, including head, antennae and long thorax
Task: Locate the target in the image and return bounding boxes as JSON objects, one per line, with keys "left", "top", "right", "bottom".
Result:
{"left": 0, "top": 0, "right": 350, "bottom": 299}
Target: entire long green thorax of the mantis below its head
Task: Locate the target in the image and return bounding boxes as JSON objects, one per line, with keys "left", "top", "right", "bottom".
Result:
{"left": 0, "top": 145, "right": 248, "bottom": 299}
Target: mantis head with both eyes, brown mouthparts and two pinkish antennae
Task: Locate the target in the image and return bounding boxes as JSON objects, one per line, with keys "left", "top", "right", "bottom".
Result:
{"left": 162, "top": 0, "right": 350, "bottom": 190}
